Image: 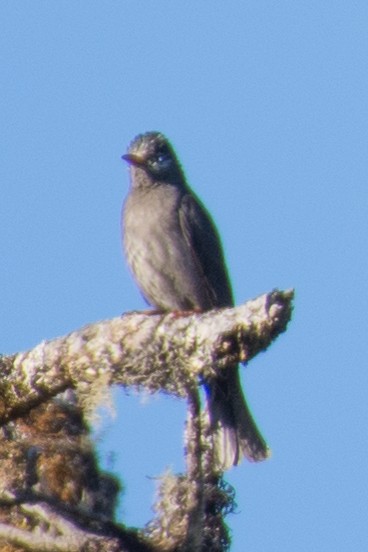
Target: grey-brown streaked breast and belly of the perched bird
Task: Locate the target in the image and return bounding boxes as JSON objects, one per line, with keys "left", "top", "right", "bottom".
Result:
{"left": 123, "top": 190, "right": 207, "bottom": 310}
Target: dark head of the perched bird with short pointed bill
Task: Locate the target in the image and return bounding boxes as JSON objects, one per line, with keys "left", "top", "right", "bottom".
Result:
{"left": 122, "top": 132, "right": 182, "bottom": 182}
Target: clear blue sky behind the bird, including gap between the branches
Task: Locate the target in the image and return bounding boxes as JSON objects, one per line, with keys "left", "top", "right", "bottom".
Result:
{"left": 0, "top": 0, "right": 368, "bottom": 552}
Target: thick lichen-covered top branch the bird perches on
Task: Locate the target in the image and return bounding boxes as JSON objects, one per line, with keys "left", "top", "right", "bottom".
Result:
{"left": 0, "top": 291, "right": 293, "bottom": 423}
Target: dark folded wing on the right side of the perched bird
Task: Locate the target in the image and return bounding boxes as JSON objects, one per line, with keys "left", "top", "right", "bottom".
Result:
{"left": 179, "top": 194, "right": 233, "bottom": 307}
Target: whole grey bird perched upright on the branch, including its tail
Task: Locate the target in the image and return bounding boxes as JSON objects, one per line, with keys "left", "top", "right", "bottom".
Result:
{"left": 122, "top": 132, "right": 269, "bottom": 469}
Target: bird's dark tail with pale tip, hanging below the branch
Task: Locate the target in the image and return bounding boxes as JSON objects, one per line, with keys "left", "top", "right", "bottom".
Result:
{"left": 206, "top": 366, "right": 270, "bottom": 470}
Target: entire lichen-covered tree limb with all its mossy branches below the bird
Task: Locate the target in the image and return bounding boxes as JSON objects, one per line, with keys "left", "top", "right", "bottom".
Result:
{"left": 0, "top": 291, "right": 292, "bottom": 552}
